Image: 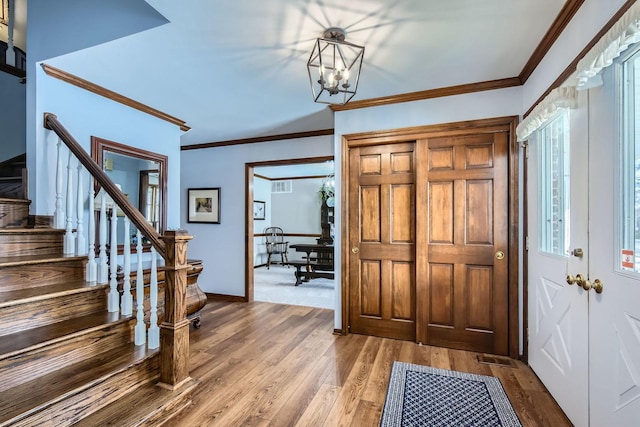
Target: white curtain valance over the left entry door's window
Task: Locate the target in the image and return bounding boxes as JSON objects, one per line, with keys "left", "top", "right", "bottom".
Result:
{"left": 516, "top": 86, "right": 578, "bottom": 141}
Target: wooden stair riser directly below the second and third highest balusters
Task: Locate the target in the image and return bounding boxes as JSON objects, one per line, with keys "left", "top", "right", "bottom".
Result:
{"left": 0, "top": 260, "right": 86, "bottom": 292}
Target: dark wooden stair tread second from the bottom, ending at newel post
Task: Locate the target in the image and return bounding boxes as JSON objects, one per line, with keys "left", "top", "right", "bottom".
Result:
{"left": 0, "top": 343, "right": 155, "bottom": 422}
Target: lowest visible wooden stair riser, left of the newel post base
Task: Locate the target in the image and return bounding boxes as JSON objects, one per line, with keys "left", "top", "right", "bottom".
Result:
{"left": 8, "top": 357, "right": 159, "bottom": 427}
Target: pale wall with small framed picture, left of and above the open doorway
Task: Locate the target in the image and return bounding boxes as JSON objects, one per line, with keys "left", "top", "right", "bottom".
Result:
{"left": 180, "top": 136, "right": 333, "bottom": 296}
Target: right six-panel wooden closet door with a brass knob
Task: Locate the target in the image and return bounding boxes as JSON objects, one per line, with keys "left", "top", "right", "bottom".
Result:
{"left": 417, "top": 132, "right": 509, "bottom": 355}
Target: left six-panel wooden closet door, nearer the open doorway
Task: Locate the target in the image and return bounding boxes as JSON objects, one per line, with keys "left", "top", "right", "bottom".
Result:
{"left": 349, "top": 143, "right": 416, "bottom": 341}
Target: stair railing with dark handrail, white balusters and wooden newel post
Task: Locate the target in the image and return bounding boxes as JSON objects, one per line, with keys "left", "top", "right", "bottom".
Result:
{"left": 44, "top": 113, "right": 192, "bottom": 390}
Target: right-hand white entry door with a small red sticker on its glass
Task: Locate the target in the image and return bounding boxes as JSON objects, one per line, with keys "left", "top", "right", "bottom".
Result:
{"left": 589, "top": 57, "right": 640, "bottom": 427}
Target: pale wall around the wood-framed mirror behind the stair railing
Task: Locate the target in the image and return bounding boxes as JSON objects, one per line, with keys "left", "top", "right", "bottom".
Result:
{"left": 27, "top": 67, "right": 182, "bottom": 236}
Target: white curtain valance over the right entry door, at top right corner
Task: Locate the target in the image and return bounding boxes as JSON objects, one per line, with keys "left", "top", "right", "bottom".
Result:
{"left": 577, "top": 3, "right": 640, "bottom": 89}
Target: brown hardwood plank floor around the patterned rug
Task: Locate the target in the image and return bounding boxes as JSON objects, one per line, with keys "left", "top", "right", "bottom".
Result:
{"left": 169, "top": 302, "right": 571, "bottom": 427}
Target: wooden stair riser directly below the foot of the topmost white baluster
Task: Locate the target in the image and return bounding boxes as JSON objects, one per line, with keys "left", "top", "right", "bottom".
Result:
{"left": 0, "top": 232, "right": 64, "bottom": 257}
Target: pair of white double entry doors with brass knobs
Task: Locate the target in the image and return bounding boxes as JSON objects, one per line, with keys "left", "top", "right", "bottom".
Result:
{"left": 527, "top": 62, "right": 640, "bottom": 427}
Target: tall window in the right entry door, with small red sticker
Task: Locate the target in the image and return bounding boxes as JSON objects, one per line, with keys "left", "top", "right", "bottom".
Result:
{"left": 618, "top": 48, "right": 640, "bottom": 272}
